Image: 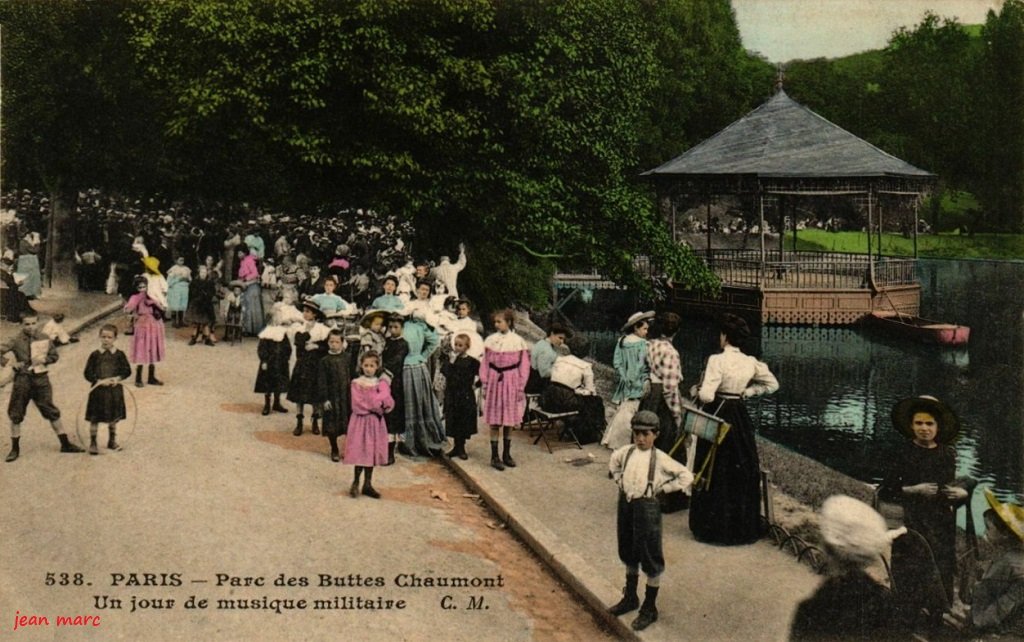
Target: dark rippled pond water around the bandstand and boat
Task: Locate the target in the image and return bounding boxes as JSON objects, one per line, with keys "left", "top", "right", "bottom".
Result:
{"left": 566, "top": 260, "right": 1024, "bottom": 516}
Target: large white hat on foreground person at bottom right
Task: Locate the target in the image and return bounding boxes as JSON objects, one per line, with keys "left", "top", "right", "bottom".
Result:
{"left": 818, "top": 495, "right": 906, "bottom": 566}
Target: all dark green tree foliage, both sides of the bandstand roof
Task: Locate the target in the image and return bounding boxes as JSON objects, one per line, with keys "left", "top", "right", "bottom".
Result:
{"left": 0, "top": 0, "right": 1011, "bottom": 304}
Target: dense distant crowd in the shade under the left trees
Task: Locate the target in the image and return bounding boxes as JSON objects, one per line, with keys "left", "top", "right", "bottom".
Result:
{"left": 0, "top": 189, "right": 423, "bottom": 323}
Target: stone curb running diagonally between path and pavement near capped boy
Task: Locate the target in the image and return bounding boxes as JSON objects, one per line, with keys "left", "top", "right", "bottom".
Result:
{"left": 441, "top": 457, "right": 643, "bottom": 640}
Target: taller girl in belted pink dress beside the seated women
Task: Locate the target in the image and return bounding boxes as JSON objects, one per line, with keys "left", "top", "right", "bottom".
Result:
{"left": 480, "top": 309, "right": 529, "bottom": 470}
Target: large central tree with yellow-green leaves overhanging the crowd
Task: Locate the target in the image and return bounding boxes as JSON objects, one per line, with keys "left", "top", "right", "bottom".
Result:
{"left": 130, "top": 0, "right": 731, "bottom": 301}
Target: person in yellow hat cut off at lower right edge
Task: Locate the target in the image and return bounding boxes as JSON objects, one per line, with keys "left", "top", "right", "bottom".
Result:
{"left": 971, "top": 488, "right": 1024, "bottom": 639}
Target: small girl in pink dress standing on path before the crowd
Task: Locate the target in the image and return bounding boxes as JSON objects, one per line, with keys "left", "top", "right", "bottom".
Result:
{"left": 344, "top": 352, "right": 394, "bottom": 500}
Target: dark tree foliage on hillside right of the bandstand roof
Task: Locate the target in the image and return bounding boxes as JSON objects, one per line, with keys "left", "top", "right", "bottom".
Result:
{"left": 786, "top": 0, "right": 1024, "bottom": 231}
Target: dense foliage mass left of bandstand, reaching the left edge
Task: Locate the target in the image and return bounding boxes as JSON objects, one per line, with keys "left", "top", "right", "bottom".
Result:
{"left": 0, "top": 0, "right": 782, "bottom": 299}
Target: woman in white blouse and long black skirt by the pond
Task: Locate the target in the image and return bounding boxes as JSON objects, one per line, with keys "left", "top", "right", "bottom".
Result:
{"left": 690, "top": 314, "right": 778, "bottom": 545}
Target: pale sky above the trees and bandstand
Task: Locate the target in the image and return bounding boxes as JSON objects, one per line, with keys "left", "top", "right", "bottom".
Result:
{"left": 732, "top": 0, "right": 1002, "bottom": 62}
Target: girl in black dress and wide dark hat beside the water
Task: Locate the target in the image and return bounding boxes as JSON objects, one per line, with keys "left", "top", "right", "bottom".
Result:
{"left": 879, "top": 395, "right": 975, "bottom": 618}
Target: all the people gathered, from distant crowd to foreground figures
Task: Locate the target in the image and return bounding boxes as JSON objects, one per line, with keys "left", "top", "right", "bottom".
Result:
{"left": 0, "top": 187, "right": 1024, "bottom": 639}
